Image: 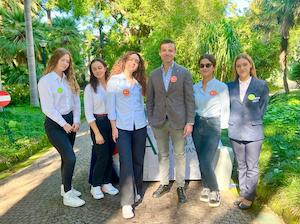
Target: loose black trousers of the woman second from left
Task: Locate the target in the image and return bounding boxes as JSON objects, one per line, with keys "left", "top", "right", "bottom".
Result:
{"left": 90, "top": 116, "right": 115, "bottom": 187}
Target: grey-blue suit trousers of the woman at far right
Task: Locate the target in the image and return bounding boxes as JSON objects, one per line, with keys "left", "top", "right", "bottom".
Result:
{"left": 230, "top": 139, "right": 263, "bottom": 201}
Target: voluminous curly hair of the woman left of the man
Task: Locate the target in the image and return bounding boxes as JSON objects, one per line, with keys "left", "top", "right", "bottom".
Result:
{"left": 111, "top": 51, "right": 146, "bottom": 96}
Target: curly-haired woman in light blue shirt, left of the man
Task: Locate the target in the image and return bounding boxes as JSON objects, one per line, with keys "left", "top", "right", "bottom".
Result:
{"left": 107, "top": 51, "right": 147, "bottom": 219}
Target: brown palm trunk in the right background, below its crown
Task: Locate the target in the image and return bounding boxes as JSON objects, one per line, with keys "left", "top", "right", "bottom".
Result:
{"left": 279, "top": 37, "right": 290, "bottom": 94}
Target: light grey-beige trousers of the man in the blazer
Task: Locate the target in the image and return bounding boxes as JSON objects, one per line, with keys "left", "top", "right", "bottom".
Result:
{"left": 152, "top": 121, "right": 185, "bottom": 187}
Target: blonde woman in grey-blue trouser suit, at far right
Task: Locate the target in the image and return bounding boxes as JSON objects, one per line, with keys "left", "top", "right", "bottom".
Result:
{"left": 228, "top": 53, "right": 269, "bottom": 209}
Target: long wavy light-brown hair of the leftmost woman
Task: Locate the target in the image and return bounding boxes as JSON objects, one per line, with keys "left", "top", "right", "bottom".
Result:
{"left": 44, "top": 48, "right": 80, "bottom": 94}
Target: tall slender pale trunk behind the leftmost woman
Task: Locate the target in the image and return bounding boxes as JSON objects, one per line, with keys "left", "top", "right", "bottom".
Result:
{"left": 24, "top": 0, "right": 39, "bottom": 107}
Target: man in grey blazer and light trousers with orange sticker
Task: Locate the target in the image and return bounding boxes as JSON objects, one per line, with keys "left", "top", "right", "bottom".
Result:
{"left": 147, "top": 40, "right": 195, "bottom": 203}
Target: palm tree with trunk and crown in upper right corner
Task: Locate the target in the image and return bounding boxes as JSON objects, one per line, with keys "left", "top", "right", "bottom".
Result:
{"left": 262, "top": 0, "right": 300, "bottom": 94}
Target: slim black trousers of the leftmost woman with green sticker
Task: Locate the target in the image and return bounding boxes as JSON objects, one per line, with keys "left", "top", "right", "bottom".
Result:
{"left": 44, "top": 112, "right": 76, "bottom": 192}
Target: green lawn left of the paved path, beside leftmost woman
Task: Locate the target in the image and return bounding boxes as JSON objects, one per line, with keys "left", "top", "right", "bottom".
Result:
{"left": 0, "top": 106, "right": 50, "bottom": 171}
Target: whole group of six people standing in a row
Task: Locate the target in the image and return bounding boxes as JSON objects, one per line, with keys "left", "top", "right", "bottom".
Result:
{"left": 38, "top": 40, "right": 268, "bottom": 219}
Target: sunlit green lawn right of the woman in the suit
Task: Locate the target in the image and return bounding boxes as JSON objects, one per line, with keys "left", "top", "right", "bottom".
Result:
{"left": 222, "top": 91, "right": 300, "bottom": 223}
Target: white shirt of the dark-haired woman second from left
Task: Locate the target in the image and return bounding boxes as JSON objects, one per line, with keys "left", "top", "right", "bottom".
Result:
{"left": 84, "top": 84, "right": 107, "bottom": 123}
